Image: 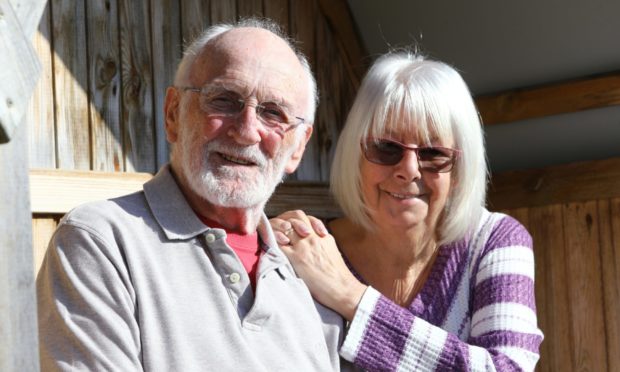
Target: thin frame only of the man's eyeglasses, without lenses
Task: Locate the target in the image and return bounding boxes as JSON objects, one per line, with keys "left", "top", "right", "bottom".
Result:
{"left": 175, "top": 85, "right": 306, "bottom": 132}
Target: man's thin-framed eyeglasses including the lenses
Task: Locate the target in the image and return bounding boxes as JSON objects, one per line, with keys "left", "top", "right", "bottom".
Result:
{"left": 179, "top": 86, "right": 306, "bottom": 132}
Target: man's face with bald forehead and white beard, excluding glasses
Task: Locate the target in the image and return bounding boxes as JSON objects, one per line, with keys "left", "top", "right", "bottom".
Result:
{"left": 166, "top": 28, "right": 312, "bottom": 208}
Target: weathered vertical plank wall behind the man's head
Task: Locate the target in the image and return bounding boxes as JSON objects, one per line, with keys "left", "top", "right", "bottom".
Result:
{"left": 29, "top": 0, "right": 363, "bottom": 181}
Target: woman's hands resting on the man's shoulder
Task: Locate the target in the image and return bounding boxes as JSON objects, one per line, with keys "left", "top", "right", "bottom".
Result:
{"left": 270, "top": 211, "right": 366, "bottom": 320}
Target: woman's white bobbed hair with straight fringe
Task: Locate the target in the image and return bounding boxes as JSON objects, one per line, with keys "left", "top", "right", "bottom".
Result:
{"left": 331, "top": 52, "right": 488, "bottom": 244}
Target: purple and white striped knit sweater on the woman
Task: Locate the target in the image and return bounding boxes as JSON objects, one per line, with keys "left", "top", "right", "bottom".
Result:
{"left": 340, "top": 210, "right": 543, "bottom": 371}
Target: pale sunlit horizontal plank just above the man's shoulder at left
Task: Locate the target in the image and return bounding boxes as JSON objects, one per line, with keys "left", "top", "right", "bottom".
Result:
{"left": 30, "top": 169, "right": 152, "bottom": 213}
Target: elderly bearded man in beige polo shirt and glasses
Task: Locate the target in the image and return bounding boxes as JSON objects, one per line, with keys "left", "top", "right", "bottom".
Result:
{"left": 37, "top": 21, "right": 342, "bottom": 371}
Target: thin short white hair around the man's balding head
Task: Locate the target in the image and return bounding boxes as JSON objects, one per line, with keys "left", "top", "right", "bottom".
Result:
{"left": 174, "top": 18, "right": 318, "bottom": 124}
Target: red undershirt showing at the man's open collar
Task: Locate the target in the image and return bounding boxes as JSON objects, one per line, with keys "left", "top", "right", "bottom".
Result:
{"left": 198, "top": 215, "right": 260, "bottom": 290}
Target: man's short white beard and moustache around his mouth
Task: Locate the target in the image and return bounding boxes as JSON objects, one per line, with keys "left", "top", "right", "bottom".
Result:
{"left": 180, "top": 136, "right": 296, "bottom": 208}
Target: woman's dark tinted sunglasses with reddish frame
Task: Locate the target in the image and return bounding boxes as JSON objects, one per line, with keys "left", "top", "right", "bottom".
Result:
{"left": 361, "top": 138, "right": 460, "bottom": 173}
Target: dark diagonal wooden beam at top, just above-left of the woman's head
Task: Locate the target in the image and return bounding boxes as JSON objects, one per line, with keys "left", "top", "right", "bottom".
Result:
{"left": 318, "top": 0, "right": 369, "bottom": 86}
